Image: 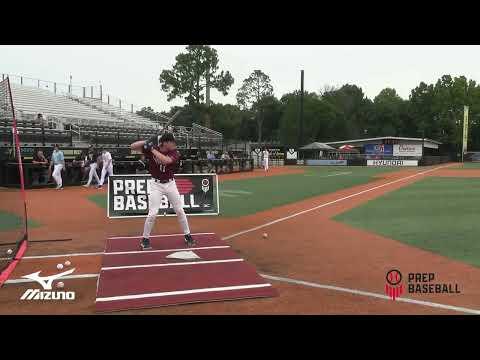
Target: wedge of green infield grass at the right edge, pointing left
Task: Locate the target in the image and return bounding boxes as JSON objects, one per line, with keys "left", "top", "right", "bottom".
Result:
{"left": 335, "top": 178, "right": 480, "bottom": 266}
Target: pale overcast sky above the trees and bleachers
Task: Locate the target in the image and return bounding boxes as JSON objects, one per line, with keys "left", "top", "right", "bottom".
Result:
{"left": 0, "top": 45, "right": 480, "bottom": 111}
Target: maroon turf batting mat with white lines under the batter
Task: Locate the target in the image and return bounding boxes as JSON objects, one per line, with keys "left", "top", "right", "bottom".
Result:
{"left": 95, "top": 233, "right": 278, "bottom": 312}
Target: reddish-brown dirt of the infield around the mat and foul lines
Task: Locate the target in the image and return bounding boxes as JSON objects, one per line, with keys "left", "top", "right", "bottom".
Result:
{"left": 0, "top": 162, "right": 480, "bottom": 314}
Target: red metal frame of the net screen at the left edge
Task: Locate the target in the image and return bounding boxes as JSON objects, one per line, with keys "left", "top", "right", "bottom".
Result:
{"left": 0, "top": 77, "right": 28, "bottom": 287}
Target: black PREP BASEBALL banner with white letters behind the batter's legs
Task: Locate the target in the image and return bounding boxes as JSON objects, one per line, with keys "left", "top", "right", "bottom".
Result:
{"left": 107, "top": 174, "right": 220, "bottom": 219}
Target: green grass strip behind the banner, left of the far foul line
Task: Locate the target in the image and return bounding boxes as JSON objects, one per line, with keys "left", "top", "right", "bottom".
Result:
{"left": 88, "top": 166, "right": 399, "bottom": 217}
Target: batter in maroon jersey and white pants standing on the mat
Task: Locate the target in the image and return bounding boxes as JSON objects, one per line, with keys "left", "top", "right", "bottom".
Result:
{"left": 130, "top": 133, "right": 195, "bottom": 250}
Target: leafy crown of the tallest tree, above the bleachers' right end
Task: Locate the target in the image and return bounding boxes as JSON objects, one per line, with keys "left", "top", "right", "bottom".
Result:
{"left": 159, "top": 45, "right": 234, "bottom": 104}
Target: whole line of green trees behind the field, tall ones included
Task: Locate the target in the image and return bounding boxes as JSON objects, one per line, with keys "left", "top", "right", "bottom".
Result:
{"left": 138, "top": 45, "right": 480, "bottom": 152}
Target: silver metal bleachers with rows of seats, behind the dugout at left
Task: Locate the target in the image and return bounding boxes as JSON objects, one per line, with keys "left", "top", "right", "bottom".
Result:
{"left": 0, "top": 77, "right": 223, "bottom": 148}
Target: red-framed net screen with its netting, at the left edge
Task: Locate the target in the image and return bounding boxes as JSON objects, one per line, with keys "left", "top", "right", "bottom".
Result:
{"left": 0, "top": 78, "right": 27, "bottom": 286}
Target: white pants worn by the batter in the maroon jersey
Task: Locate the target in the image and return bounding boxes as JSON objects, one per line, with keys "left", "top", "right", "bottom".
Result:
{"left": 143, "top": 180, "right": 190, "bottom": 238}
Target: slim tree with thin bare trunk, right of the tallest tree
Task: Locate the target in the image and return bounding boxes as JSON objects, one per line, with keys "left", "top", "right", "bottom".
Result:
{"left": 237, "top": 70, "right": 273, "bottom": 142}
